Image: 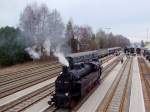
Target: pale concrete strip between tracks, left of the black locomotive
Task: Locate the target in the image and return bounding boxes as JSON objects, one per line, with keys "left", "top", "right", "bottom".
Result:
{"left": 0, "top": 77, "right": 57, "bottom": 106}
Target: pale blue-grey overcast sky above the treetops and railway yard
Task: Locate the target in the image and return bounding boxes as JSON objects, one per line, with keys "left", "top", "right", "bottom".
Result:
{"left": 0, "top": 0, "right": 150, "bottom": 41}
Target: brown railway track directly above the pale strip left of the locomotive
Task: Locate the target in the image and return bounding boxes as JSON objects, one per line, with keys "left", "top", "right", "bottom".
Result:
{"left": 0, "top": 69, "right": 61, "bottom": 98}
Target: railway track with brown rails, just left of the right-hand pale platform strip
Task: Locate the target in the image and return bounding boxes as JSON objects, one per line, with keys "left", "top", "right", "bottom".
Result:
{"left": 97, "top": 58, "right": 133, "bottom": 112}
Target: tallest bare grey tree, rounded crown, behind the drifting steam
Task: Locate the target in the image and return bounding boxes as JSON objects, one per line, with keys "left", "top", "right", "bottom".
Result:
{"left": 20, "top": 4, "right": 64, "bottom": 57}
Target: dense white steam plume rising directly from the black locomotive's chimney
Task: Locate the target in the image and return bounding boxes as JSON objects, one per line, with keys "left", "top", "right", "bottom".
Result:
{"left": 54, "top": 47, "right": 69, "bottom": 67}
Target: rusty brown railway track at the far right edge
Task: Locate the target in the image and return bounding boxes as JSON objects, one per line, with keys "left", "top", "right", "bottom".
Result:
{"left": 138, "top": 57, "right": 150, "bottom": 112}
